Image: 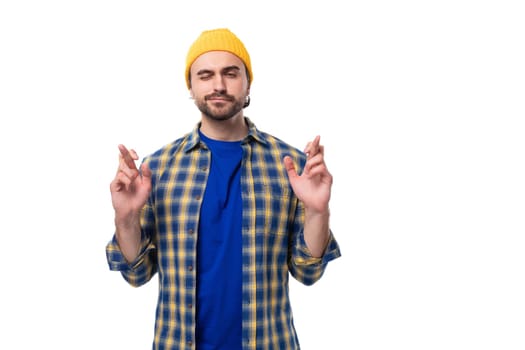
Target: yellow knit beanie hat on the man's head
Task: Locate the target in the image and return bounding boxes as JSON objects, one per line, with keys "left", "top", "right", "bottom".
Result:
{"left": 186, "top": 28, "right": 253, "bottom": 89}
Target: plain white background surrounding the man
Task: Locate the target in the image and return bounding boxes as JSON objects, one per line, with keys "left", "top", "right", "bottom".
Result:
{"left": 0, "top": 0, "right": 525, "bottom": 350}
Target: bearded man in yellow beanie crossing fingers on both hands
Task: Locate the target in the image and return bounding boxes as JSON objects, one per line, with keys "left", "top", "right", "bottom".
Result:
{"left": 106, "top": 28, "right": 340, "bottom": 350}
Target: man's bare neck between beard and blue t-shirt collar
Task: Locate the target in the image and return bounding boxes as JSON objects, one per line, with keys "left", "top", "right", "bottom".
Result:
{"left": 200, "top": 113, "right": 248, "bottom": 141}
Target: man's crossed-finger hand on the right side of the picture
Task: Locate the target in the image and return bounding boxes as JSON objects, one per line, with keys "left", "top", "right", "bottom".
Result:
{"left": 283, "top": 136, "right": 333, "bottom": 214}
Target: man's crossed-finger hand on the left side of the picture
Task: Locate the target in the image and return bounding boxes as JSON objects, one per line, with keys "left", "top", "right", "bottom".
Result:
{"left": 110, "top": 145, "right": 151, "bottom": 219}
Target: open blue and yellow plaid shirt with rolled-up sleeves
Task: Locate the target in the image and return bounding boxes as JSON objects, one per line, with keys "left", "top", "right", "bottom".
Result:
{"left": 106, "top": 118, "right": 341, "bottom": 350}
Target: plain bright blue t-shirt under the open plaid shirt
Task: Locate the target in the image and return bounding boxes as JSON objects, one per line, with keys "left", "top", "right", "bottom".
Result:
{"left": 196, "top": 133, "right": 242, "bottom": 350}
